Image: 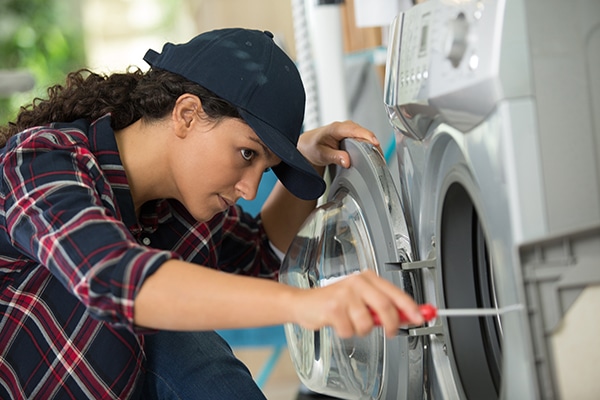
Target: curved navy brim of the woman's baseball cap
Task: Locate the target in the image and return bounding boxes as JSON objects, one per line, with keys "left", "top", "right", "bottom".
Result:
{"left": 238, "top": 108, "right": 326, "bottom": 200}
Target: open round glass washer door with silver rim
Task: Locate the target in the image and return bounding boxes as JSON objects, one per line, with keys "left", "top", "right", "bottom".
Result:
{"left": 280, "top": 139, "right": 423, "bottom": 400}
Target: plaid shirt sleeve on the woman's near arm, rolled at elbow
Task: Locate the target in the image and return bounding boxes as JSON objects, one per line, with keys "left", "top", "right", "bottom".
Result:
{"left": 0, "top": 133, "right": 175, "bottom": 330}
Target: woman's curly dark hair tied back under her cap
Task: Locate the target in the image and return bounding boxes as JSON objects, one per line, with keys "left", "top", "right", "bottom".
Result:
{"left": 0, "top": 69, "right": 241, "bottom": 147}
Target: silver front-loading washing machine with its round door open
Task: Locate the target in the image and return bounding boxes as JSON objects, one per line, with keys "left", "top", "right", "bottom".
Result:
{"left": 280, "top": 0, "right": 600, "bottom": 400}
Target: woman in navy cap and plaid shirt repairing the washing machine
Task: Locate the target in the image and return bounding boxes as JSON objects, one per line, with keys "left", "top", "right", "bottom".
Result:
{"left": 0, "top": 29, "right": 422, "bottom": 399}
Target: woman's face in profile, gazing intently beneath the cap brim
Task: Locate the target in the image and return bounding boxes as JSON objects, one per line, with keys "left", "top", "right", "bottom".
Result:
{"left": 171, "top": 118, "right": 281, "bottom": 221}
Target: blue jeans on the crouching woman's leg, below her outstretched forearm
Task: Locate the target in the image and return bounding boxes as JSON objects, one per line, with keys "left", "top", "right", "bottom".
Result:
{"left": 142, "top": 331, "right": 266, "bottom": 400}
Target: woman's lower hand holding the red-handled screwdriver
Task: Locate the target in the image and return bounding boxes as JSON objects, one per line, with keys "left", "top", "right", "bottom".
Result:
{"left": 292, "top": 271, "right": 424, "bottom": 338}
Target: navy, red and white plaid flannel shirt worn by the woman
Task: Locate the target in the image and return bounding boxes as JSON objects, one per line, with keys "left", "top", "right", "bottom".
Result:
{"left": 0, "top": 116, "right": 279, "bottom": 399}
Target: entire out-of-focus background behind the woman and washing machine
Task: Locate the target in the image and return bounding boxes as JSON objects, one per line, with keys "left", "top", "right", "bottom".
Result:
{"left": 0, "top": 0, "right": 402, "bottom": 400}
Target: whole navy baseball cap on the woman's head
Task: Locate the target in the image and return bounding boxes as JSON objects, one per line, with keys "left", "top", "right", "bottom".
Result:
{"left": 144, "top": 28, "right": 325, "bottom": 200}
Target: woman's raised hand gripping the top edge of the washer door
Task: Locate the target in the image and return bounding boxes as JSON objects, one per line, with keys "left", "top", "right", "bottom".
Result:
{"left": 298, "top": 121, "right": 381, "bottom": 169}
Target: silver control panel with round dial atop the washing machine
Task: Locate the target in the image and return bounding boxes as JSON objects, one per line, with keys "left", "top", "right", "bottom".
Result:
{"left": 384, "top": 0, "right": 529, "bottom": 139}
